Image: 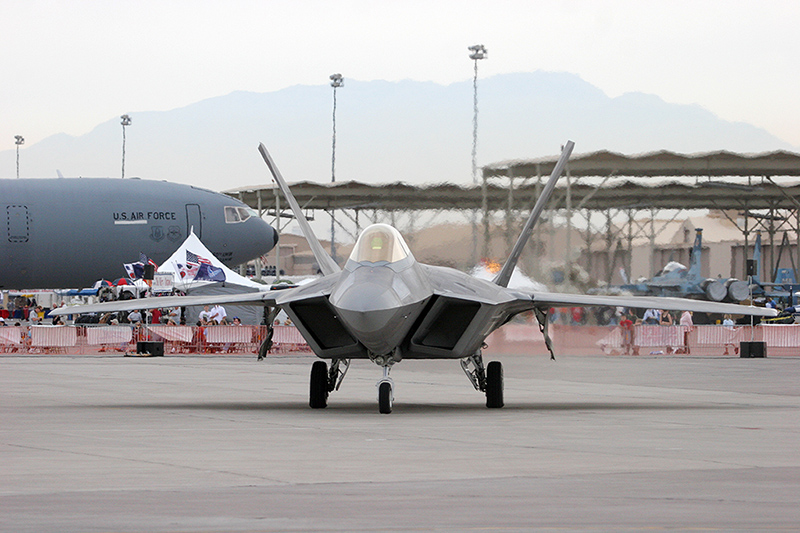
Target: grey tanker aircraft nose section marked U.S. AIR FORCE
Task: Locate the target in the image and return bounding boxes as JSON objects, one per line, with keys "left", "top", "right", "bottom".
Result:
{"left": 0, "top": 178, "right": 278, "bottom": 289}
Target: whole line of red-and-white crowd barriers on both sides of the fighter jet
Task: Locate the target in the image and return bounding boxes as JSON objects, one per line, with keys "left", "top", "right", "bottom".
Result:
{"left": 0, "top": 323, "right": 800, "bottom": 356}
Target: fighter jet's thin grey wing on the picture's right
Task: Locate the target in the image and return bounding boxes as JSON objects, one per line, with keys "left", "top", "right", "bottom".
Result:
{"left": 530, "top": 292, "right": 778, "bottom": 317}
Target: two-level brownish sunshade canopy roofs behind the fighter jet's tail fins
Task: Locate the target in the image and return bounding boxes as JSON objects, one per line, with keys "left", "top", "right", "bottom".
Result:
{"left": 223, "top": 151, "right": 800, "bottom": 211}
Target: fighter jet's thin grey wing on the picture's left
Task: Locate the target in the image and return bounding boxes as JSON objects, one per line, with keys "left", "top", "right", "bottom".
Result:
{"left": 50, "top": 289, "right": 282, "bottom": 315}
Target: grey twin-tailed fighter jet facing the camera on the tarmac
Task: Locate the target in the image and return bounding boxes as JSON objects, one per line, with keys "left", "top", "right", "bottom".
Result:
{"left": 50, "top": 141, "right": 775, "bottom": 413}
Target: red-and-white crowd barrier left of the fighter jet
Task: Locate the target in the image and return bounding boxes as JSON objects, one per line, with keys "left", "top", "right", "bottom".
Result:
{"left": 0, "top": 325, "right": 309, "bottom": 355}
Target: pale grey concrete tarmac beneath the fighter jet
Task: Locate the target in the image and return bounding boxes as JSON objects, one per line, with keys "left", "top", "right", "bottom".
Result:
{"left": 0, "top": 355, "right": 800, "bottom": 532}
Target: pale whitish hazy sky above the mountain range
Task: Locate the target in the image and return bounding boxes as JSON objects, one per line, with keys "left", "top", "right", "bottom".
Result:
{"left": 0, "top": 0, "right": 800, "bottom": 154}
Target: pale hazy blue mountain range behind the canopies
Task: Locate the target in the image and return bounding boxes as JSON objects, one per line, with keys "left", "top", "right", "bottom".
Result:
{"left": 0, "top": 71, "right": 796, "bottom": 190}
